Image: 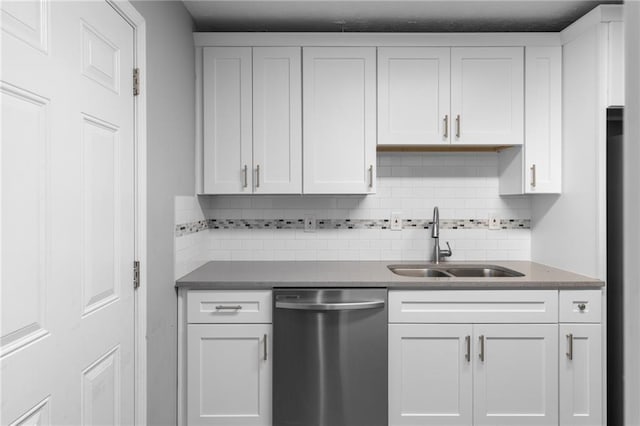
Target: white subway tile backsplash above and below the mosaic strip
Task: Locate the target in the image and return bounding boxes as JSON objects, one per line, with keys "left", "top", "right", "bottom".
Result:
{"left": 175, "top": 153, "right": 531, "bottom": 278}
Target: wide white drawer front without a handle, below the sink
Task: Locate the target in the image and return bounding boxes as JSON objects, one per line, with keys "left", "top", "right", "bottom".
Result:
{"left": 389, "top": 290, "right": 558, "bottom": 323}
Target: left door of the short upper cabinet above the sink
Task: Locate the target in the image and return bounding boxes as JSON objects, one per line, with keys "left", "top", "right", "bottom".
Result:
{"left": 378, "top": 47, "right": 451, "bottom": 145}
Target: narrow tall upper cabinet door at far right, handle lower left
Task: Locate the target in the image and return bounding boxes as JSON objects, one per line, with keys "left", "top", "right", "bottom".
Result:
{"left": 523, "top": 46, "right": 562, "bottom": 194}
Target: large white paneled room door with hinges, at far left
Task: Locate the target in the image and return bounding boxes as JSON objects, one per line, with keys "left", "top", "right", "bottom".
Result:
{"left": 0, "top": 0, "right": 135, "bottom": 425}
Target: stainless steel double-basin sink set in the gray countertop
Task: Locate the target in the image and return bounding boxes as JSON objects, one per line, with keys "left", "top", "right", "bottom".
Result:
{"left": 387, "top": 263, "right": 524, "bottom": 278}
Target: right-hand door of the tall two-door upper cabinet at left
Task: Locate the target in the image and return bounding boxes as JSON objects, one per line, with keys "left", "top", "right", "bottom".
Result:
{"left": 253, "top": 47, "right": 302, "bottom": 194}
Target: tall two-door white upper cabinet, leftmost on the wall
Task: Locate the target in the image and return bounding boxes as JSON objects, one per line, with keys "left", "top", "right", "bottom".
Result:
{"left": 202, "top": 47, "right": 302, "bottom": 194}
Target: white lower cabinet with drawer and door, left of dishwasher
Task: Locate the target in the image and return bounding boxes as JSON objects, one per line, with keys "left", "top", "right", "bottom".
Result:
{"left": 186, "top": 290, "right": 273, "bottom": 426}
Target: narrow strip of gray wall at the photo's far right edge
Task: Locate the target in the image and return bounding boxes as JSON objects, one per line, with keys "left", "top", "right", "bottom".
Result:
{"left": 624, "top": 1, "right": 640, "bottom": 425}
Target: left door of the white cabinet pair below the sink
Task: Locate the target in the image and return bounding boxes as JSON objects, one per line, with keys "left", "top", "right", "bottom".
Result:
{"left": 389, "top": 324, "right": 473, "bottom": 426}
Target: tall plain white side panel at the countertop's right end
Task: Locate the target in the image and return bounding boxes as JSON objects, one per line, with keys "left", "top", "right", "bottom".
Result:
{"left": 531, "top": 19, "right": 606, "bottom": 279}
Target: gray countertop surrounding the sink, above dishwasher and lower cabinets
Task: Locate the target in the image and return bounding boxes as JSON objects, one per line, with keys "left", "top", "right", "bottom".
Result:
{"left": 176, "top": 261, "right": 604, "bottom": 290}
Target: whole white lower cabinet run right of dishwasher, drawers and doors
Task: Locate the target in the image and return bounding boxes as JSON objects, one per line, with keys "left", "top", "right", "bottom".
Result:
{"left": 389, "top": 290, "right": 603, "bottom": 426}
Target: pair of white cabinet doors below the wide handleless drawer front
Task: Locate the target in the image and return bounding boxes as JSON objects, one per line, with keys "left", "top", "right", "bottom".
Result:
{"left": 389, "top": 324, "right": 558, "bottom": 426}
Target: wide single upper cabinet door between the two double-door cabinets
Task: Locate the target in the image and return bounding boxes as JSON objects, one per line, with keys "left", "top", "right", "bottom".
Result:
{"left": 302, "top": 47, "right": 376, "bottom": 194}
